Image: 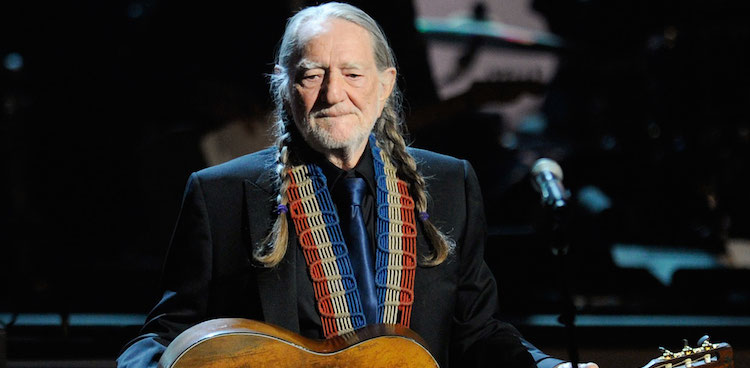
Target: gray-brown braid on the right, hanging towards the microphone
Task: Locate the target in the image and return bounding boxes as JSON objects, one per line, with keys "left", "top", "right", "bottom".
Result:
{"left": 375, "top": 104, "right": 455, "bottom": 266}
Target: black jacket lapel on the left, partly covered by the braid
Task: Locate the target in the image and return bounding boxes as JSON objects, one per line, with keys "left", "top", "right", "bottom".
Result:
{"left": 245, "top": 170, "right": 299, "bottom": 332}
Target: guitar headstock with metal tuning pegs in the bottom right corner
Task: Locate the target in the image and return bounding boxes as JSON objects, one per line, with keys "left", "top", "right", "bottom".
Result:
{"left": 643, "top": 336, "right": 734, "bottom": 368}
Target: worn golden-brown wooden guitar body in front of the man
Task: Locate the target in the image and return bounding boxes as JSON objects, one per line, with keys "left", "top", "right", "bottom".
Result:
{"left": 159, "top": 318, "right": 438, "bottom": 368}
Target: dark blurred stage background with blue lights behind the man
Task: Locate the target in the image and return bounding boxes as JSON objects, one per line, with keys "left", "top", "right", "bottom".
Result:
{"left": 0, "top": 0, "right": 750, "bottom": 367}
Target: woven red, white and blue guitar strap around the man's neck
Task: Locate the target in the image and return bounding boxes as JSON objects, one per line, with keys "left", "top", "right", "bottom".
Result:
{"left": 287, "top": 135, "right": 417, "bottom": 338}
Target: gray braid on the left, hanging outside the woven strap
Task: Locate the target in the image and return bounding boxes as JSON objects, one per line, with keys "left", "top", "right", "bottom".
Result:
{"left": 253, "top": 121, "right": 291, "bottom": 267}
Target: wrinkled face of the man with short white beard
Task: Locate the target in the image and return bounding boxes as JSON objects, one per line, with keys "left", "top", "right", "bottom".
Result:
{"left": 291, "top": 18, "right": 396, "bottom": 158}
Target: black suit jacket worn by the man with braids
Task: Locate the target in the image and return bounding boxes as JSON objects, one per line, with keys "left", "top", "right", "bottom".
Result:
{"left": 118, "top": 149, "right": 560, "bottom": 367}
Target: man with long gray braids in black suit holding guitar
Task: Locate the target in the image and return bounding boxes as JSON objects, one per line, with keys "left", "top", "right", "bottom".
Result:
{"left": 118, "top": 3, "right": 595, "bottom": 367}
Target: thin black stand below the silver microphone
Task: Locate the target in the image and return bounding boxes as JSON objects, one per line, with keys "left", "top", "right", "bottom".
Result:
{"left": 542, "top": 202, "right": 579, "bottom": 368}
